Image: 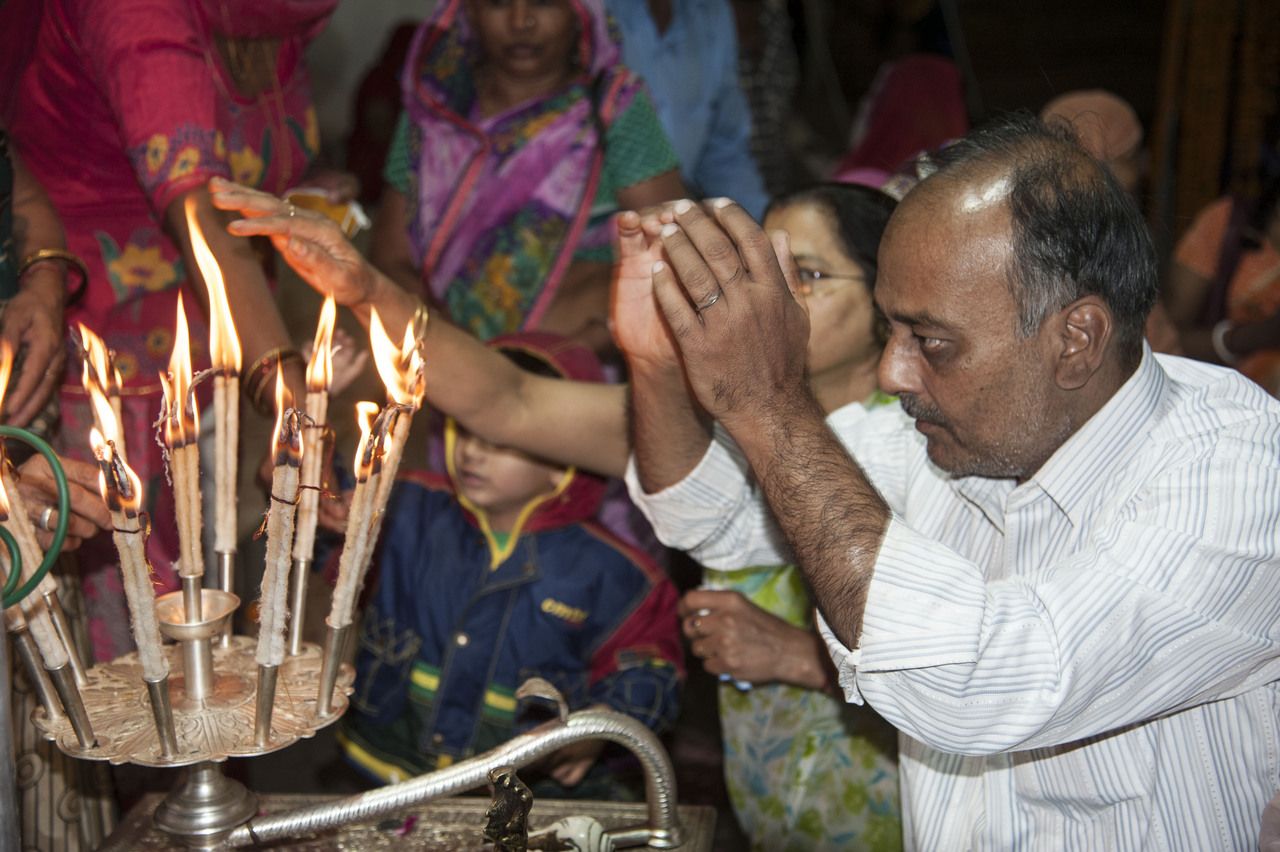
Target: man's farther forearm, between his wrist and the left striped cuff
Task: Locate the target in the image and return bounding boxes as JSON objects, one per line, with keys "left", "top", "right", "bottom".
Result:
{"left": 628, "top": 355, "right": 712, "bottom": 494}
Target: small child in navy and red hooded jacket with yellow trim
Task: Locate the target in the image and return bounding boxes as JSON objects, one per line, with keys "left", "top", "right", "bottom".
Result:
{"left": 339, "top": 333, "right": 682, "bottom": 798}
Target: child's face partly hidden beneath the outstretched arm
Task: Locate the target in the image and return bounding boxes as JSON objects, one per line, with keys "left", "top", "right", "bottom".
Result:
{"left": 453, "top": 427, "right": 564, "bottom": 532}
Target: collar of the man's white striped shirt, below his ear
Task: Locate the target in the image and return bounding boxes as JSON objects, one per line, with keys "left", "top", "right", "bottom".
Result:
{"left": 1019, "top": 343, "right": 1169, "bottom": 527}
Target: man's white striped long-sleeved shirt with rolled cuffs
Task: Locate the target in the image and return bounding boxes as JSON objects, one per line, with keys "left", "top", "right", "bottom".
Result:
{"left": 628, "top": 351, "right": 1280, "bottom": 852}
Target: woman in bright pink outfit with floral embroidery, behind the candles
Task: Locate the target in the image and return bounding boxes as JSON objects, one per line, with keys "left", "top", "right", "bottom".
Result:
{"left": 12, "top": 0, "right": 337, "bottom": 659}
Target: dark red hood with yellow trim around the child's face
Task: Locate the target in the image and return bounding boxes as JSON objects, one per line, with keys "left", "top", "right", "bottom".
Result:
{"left": 444, "top": 331, "right": 607, "bottom": 568}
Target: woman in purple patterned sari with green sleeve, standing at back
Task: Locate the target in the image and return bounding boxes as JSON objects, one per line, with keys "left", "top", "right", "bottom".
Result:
{"left": 372, "top": 0, "right": 685, "bottom": 349}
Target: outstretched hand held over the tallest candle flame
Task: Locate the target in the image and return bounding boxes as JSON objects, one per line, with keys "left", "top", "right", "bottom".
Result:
{"left": 209, "top": 178, "right": 378, "bottom": 306}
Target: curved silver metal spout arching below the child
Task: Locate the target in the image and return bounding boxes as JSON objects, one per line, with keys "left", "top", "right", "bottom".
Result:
{"left": 225, "top": 707, "right": 684, "bottom": 849}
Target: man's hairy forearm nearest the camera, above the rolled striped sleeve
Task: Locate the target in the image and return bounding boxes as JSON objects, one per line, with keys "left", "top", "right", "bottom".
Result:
{"left": 730, "top": 399, "right": 890, "bottom": 647}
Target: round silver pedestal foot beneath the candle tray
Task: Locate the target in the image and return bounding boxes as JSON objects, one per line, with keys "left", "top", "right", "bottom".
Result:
{"left": 155, "top": 761, "right": 257, "bottom": 849}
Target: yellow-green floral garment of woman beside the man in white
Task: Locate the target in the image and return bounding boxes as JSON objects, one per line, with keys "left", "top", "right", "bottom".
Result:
{"left": 716, "top": 565, "right": 902, "bottom": 852}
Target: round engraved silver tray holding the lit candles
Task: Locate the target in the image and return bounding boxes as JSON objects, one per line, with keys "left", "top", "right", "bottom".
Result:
{"left": 32, "top": 636, "right": 353, "bottom": 766}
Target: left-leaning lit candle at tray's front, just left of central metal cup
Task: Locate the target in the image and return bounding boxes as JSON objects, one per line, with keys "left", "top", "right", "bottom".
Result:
{"left": 90, "top": 429, "right": 169, "bottom": 682}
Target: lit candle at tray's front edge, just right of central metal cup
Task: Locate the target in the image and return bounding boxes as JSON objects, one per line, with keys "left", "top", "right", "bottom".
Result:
{"left": 256, "top": 367, "right": 303, "bottom": 665}
